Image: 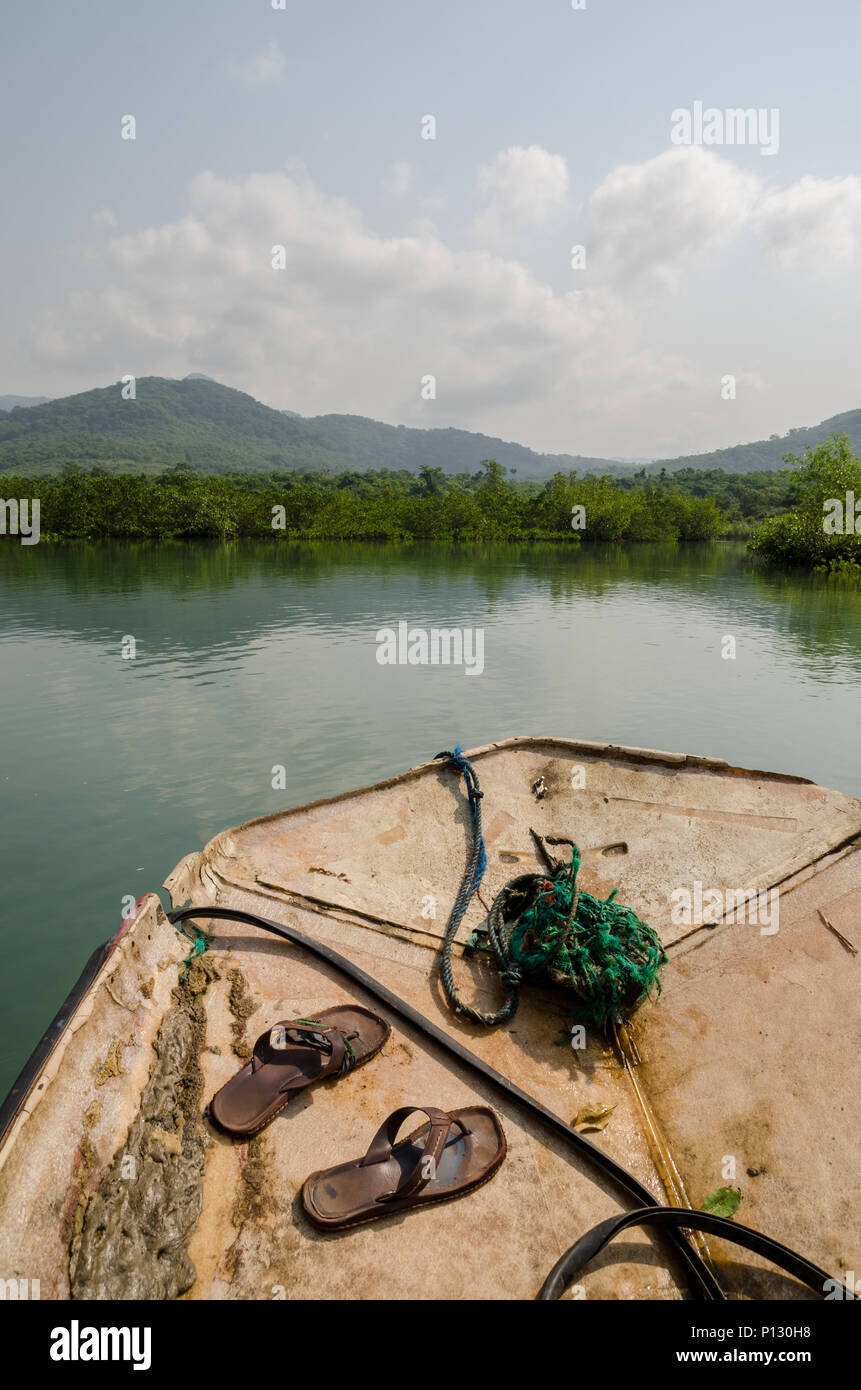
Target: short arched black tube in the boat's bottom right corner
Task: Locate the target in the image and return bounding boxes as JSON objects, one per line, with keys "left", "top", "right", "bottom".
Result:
{"left": 538, "top": 1207, "right": 854, "bottom": 1302}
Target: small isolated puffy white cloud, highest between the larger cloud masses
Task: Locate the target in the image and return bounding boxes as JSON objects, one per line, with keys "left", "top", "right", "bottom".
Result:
{"left": 473, "top": 145, "right": 569, "bottom": 247}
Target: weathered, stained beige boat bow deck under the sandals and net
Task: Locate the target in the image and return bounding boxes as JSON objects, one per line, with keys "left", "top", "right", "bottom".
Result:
{"left": 0, "top": 738, "right": 861, "bottom": 1300}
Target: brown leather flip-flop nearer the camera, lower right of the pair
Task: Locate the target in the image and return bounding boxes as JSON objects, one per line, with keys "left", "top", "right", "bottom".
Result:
{"left": 302, "top": 1105, "right": 506, "bottom": 1230}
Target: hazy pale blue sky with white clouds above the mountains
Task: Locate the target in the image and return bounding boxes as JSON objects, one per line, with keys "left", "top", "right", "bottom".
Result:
{"left": 0, "top": 0, "right": 861, "bottom": 456}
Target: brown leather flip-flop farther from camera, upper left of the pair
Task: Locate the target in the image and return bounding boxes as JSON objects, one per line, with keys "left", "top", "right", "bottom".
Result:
{"left": 209, "top": 1004, "right": 391, "bottom": 1138}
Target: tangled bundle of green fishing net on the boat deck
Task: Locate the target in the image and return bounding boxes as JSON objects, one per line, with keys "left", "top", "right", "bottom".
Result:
{"left": 497, "top": 845, "right": 666, "bottom": 1029}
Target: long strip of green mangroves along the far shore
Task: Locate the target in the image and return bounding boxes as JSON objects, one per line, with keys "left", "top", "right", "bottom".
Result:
{"left": 0, "top": 459, "right": 745, "bottom": 543}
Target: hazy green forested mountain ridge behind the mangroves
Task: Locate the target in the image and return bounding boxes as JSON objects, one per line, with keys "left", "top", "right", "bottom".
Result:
{"left": 0, "top": 373, "right": 861, "bottom": 478}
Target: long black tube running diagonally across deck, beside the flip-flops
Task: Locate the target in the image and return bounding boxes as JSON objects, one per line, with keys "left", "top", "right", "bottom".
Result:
{"left": 167, "top": 908, "right": 726, "bottom": 1301}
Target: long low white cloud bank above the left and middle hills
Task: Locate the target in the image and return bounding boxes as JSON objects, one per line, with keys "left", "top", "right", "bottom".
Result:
{"left": 35, "top": 166, "right": 655, "bottom": 448}
